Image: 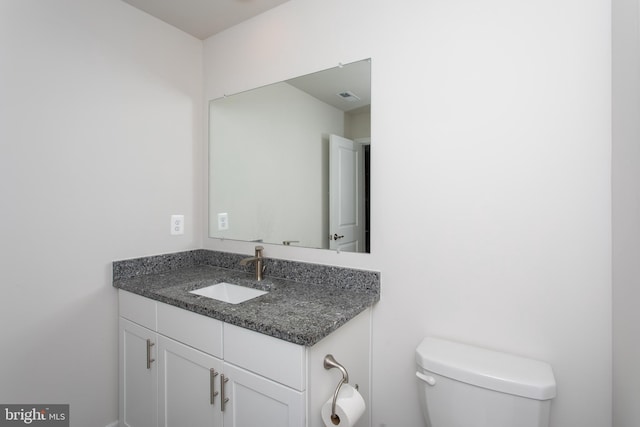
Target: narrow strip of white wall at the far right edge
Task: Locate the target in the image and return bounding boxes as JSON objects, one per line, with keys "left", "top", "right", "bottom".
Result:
{"left": 613, "top": 0, "right": 640, "bottom": 427}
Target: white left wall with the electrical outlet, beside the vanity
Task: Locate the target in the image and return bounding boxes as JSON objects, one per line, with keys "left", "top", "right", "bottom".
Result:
{"left": 0, "top": 0, "right": 204, "bottom": 427}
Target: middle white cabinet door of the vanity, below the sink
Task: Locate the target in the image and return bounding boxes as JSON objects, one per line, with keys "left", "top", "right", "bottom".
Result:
{"left": 158, "top": 335, "right": 222, "bottom": 427}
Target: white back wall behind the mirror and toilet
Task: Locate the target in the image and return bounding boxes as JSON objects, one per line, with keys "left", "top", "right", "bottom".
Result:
{"left": 203, "top": 0, "right": 611, "bottom": 427}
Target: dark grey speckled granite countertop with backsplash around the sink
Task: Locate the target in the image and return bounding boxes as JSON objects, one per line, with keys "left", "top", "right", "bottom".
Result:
{"left": 113, "top": 249, "right": 380, "bottom": 346}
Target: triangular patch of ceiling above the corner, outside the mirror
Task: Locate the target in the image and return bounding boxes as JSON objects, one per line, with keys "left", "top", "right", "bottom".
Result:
{"left": 122, "top": 0, "right": 288, "bottom": 40}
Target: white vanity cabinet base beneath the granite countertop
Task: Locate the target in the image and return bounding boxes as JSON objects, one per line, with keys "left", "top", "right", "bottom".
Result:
{"left": 119, "top": 290, "right": 370, "bottom": 427}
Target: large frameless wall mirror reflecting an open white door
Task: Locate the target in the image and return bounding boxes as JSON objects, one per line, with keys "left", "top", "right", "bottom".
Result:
{"left": 209, "top": 60, "right": 371, "bottom": 252}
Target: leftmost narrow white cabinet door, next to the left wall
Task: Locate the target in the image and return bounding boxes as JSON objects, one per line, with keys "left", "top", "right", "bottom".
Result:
{"left": 119, "top": 317, "right": 158, "bottom": 427}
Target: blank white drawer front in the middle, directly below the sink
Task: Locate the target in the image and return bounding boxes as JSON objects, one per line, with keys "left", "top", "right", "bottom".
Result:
{"left": 158, "top": 302, "right": 222, "bottom": 358}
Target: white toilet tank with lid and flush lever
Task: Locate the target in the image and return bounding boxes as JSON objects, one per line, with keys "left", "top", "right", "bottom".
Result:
{"left": 416, "top": 337, "right": 556, "bottom": 427}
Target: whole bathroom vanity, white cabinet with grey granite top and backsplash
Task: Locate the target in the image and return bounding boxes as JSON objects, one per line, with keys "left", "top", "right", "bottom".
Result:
{"left": 114, "top": 250, "right": 379, "bottom": 427}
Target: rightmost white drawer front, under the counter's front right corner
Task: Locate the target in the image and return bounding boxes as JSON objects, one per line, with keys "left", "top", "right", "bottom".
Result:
{"left": 224, "top": 324, "right": 306, "bottom": 391}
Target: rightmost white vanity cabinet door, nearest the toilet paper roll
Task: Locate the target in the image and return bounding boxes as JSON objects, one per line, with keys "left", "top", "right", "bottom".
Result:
{"left": 224, "top": 363, "right": 305, "bottom": 427}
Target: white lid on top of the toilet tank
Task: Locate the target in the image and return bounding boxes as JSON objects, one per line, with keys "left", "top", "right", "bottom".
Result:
{"left": 416, "top": 337, "right": 556, "bottom": 400}
